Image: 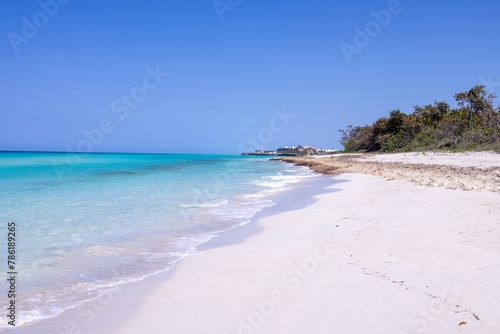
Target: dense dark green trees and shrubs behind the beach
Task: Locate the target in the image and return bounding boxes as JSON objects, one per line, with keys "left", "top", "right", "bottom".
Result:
{"left": 339, "top": 86, "right": 500, "bottom": 152}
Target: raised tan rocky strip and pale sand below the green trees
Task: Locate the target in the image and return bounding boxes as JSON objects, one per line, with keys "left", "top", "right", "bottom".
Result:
{"left": 278, "top": 152, "right": 500, "bottom": 192}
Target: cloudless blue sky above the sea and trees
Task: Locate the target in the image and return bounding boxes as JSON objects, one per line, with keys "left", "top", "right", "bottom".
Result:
{"left": 0, "top": 0, "right": 500, "bottom": 153}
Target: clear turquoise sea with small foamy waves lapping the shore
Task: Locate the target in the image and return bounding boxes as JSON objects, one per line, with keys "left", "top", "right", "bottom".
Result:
{"left": 0, "top": 153, "right": 314, "bottom": 325}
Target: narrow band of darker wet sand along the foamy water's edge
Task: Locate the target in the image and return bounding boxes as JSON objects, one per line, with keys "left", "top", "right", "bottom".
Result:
{"left": 16, "top": 175, "right": 333, "bottom": 334}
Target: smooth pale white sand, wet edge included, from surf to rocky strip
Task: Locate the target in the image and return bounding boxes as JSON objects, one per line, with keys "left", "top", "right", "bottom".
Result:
{"left": 16, "top": 153, "right": 500, "bottom": 334}
